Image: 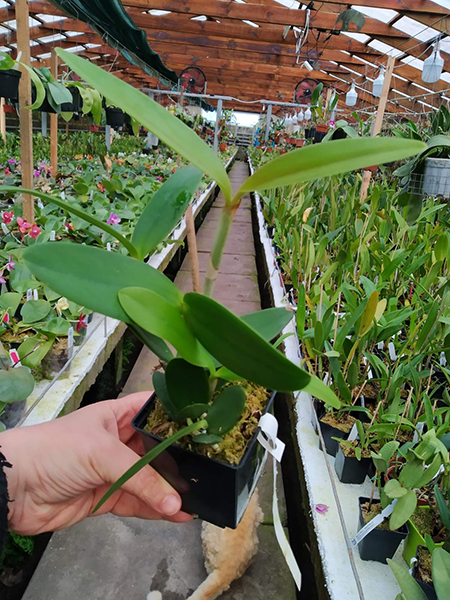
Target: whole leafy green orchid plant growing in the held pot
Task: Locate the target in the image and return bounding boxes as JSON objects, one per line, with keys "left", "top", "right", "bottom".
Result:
{"left": 0, "top": 50, "right": 423, "bottom": 504}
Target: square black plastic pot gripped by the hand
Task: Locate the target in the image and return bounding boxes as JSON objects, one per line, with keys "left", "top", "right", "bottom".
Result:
{"left": 132, "top": 393, "right": 276, "bottom": 529}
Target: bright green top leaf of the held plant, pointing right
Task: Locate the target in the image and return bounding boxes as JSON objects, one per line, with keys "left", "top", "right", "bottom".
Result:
{"left": 238, "top": 137, "right": 425, "bottom": 196}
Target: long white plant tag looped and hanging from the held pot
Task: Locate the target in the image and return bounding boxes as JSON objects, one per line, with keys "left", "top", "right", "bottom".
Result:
{"left": 258, "top": 413, "right": 302, "bottom": 591}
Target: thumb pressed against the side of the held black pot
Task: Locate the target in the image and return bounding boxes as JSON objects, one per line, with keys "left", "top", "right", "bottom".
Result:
{"left": 97, "top": 437, "right": 181, "bottom": 516}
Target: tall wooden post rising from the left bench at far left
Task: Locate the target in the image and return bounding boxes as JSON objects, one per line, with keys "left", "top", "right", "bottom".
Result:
{"left": 16, "top": 0, "right": 34, "bottom": 223}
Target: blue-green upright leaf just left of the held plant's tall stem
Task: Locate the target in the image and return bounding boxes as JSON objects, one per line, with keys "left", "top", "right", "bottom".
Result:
{"left": 132, "top": 167, "right": 202, "bottom": 259}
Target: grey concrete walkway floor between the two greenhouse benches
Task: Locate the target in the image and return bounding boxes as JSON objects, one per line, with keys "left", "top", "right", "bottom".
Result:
{"left": 23, "top": 162, "right": 295, "bottom": 600}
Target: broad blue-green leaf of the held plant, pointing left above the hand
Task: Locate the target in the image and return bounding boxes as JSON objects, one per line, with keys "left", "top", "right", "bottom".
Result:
{"left": 23, "top": 242, "right": 182, "bottom": 323}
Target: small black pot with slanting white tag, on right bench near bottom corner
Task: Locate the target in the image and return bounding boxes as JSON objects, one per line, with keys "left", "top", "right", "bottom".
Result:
{"left": 358, "top": 497, "right": 408, "bottom": 564}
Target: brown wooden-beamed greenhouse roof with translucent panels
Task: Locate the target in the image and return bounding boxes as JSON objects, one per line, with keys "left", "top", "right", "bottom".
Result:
{"left": 0, "top": 0, "right": 450, "bottom": 116}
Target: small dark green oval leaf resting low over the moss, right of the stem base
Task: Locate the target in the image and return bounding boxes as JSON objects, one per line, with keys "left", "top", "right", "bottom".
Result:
{"left": 207, "top": 385, "right": 246, "bottom": 435}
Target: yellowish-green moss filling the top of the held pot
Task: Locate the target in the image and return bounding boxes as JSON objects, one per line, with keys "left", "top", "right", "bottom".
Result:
{"left": 145, "top": 382, "right": 269, "bottom": 465}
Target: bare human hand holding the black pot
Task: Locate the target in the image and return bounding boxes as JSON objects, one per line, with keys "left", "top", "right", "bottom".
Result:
{"left": 0, "top": 392, "right": 191, "bottom": 535}
